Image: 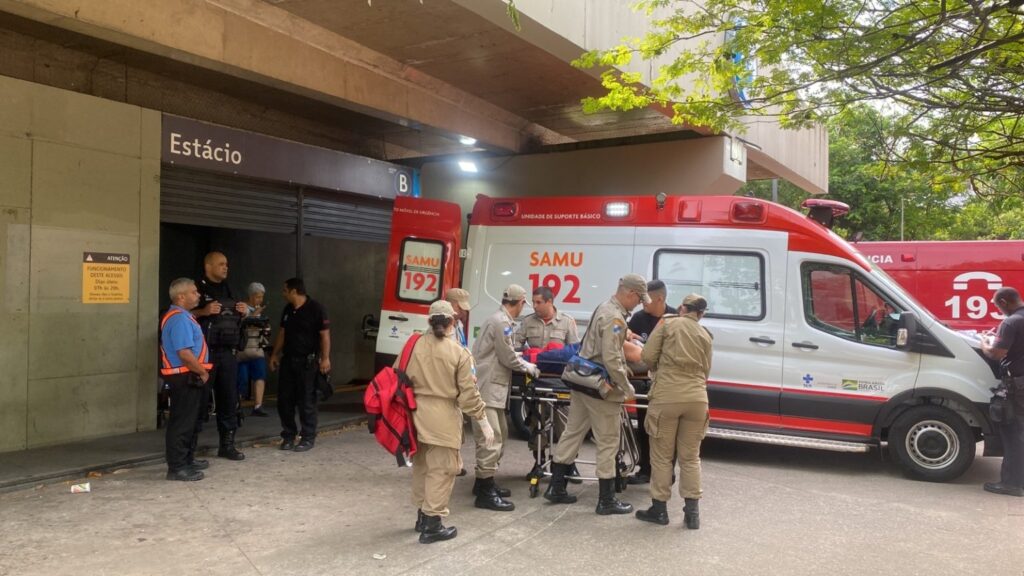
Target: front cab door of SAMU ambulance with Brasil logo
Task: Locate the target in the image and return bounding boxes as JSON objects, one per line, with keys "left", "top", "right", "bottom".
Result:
{"left": 780, "top": 252, "right": 921, "bottom": 439}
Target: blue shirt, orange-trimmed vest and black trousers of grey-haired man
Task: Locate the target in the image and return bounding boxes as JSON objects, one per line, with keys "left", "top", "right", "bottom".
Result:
{"left": 160, "top": 305, "right": 211, "bottom": 478}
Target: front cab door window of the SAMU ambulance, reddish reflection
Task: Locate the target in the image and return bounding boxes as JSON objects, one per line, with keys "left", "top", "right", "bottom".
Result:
{"left": 801, "top": 263, "right": 899, "bottom": 347}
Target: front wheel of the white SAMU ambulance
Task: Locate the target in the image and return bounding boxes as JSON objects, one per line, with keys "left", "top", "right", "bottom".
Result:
{"left": 889, "top": 406, "right": 977, "bottom": 482}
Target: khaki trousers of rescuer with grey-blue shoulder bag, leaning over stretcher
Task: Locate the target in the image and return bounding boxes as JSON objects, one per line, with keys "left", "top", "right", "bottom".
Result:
{"left": 553, "top": 392, "right": 623, "bottom": 480}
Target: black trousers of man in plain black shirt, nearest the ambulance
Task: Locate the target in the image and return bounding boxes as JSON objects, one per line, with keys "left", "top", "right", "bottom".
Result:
{"left": 278, "top": 356, "right": 319, "bottom": 441}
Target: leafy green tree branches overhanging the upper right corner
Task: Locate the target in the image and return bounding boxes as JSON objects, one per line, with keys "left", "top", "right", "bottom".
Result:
{"left": 577, "top": 0, "right": 1024, "bottom": 189}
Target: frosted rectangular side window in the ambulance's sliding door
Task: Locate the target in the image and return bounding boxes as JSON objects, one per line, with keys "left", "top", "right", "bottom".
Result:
{"left": 654, "top": 250, "right": 765, "bottom": 321}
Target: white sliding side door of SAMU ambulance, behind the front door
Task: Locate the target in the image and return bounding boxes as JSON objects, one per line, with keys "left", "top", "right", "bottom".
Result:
{"left": 636, "top": 228, "right": 786, "bottom": 429}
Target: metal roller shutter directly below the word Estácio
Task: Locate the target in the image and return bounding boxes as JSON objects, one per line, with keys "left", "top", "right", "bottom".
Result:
{"left": 160, "top": 164, "right": 298, "bottom": 234}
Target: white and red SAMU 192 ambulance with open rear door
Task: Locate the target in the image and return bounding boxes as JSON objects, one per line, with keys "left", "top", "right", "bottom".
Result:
{"left": 377, "top": 194, "right": 1001, "bottom": 482}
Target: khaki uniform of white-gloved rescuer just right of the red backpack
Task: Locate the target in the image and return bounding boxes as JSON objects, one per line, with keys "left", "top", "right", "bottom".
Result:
{"left": 473, "top": 306, "right": 531, "bottom": 479}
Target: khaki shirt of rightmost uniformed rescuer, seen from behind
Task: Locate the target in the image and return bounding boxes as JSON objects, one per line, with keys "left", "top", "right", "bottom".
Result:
{"left": 642, "top": 314, "right": 712, "bottom": 406}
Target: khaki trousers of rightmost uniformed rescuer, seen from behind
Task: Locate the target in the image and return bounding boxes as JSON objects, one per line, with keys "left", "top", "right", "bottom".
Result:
{"left": 644, "top": 402, "right": 711, "bottom": 502}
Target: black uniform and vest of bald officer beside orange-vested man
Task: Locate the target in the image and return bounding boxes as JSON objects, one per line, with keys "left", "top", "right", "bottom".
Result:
{"left": 196, "top": 277, "right": 245, "bottom": 460}
